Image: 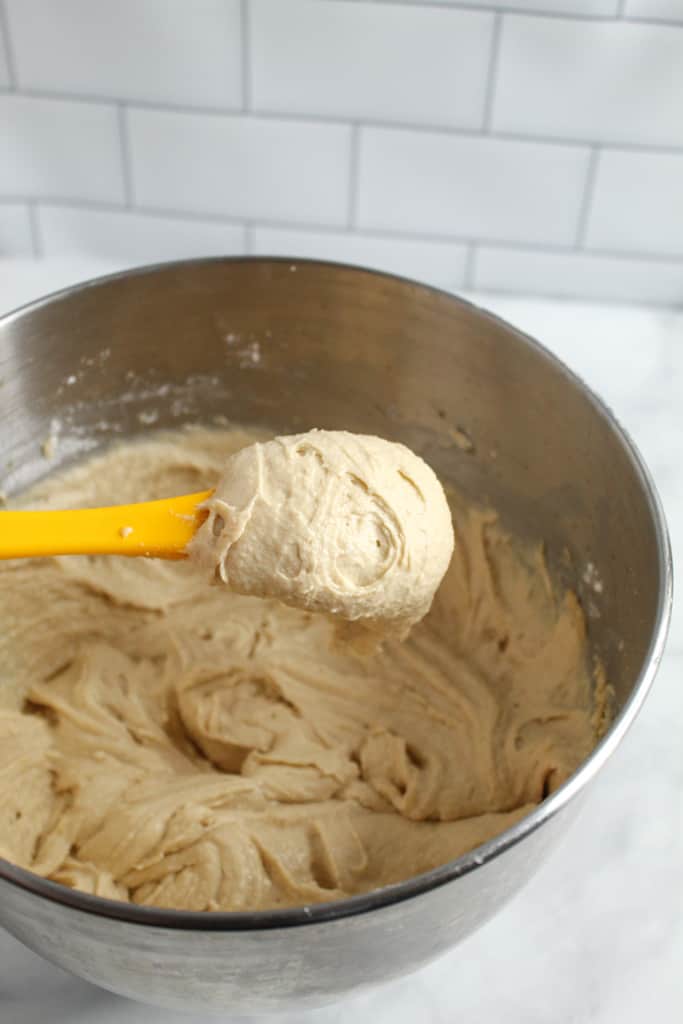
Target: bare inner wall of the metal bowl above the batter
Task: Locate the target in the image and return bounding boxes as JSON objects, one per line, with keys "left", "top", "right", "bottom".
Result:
{"left": 0, "top": 259, "right": 661, "bottom": 709}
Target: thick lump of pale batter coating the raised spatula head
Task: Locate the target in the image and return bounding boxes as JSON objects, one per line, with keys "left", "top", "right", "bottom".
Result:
{"left": 189, "top": 430, "right": 453, "bottom": 637}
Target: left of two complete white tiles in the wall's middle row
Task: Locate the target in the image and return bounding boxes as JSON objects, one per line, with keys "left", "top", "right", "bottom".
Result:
{"left": 130, "top": 110, "right": 350, "bottom": 225}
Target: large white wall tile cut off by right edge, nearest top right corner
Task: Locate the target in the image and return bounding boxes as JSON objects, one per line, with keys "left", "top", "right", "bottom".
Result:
{"left": 493, "top": 15, "right": 683, "bottom": 145}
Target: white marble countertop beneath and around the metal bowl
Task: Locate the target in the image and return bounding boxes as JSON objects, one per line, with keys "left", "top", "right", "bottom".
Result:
{"left": 0, "top": 262, "right": 683, "bottom": 1024}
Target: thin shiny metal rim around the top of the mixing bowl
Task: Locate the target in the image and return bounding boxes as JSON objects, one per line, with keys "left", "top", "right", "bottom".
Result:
{"left": 0, "top": 256, "right": 674, "bottom": 933}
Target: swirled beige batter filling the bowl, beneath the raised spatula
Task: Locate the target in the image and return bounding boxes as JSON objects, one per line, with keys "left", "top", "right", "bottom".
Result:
{"left": 0, "top": 431, "right": 601, "bottom": 910}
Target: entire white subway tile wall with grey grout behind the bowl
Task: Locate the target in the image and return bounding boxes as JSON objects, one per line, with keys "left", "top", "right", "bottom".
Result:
{"left": 0, "top": 0, "right": 683, "bottom": 305}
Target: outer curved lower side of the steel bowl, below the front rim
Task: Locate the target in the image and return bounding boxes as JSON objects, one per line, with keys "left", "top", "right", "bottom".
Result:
{"left": 0, "top": 801, "right": 581, "bottom": 1015}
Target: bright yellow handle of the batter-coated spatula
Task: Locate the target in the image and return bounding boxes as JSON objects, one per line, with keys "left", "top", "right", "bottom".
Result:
{"left": 0, "top": 490, "right": 213, "bottom": 559}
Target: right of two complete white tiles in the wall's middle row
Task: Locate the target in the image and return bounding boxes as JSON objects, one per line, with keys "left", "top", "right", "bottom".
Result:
{"left": 358, "top": 128, "right": 589, "bottom": 244}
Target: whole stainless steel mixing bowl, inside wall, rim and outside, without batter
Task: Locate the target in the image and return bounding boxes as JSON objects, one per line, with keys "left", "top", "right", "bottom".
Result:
{"left": 0, "top": 259, "right": 672, "bottom": 1013}
